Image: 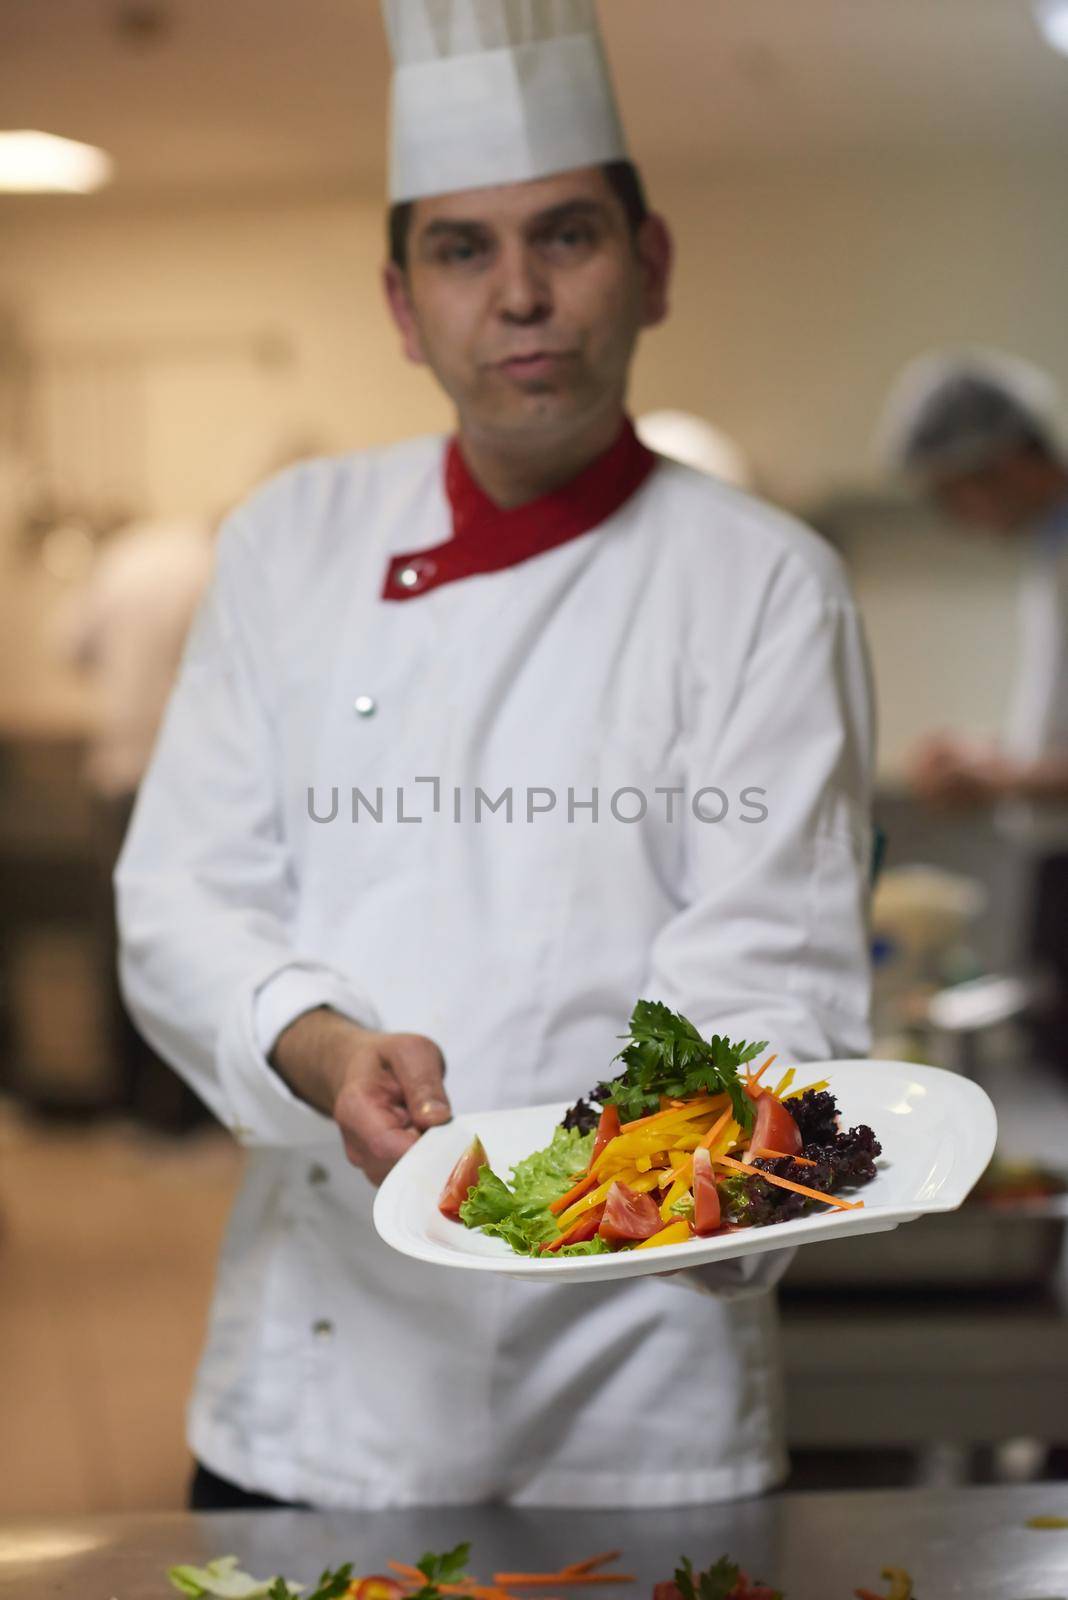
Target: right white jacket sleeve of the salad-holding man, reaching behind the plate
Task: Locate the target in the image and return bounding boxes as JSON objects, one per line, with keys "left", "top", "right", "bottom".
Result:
{"left": 643, "top": 537, "right": 873, "bottom": 1298}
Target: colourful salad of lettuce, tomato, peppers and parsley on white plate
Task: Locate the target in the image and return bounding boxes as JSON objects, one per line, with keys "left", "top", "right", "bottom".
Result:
{"left": 438, "top": 1000, "right": 881, "bottom": 1258}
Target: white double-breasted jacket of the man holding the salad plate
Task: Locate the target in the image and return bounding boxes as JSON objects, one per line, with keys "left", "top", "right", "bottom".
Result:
{"left": 117, "top": 438, "right": 873, "bottom": 1507}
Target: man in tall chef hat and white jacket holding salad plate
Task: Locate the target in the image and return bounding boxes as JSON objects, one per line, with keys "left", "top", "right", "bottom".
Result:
{"left": 117, "top": 0, "right": 871, "bottom": 1507}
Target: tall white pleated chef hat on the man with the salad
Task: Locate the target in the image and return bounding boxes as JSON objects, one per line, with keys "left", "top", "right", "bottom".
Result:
{"left": 382, "top": 0, "right": 627, "bottom": 202}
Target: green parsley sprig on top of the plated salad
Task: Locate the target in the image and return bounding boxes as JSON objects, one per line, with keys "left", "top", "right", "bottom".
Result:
{"left": 604, "top": 1000, "right": 767, "bottom": 1126}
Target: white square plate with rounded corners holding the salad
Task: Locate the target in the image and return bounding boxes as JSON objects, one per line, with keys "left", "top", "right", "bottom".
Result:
{"left": 374, "top": 1061, "right": 998, "bottom": 1283}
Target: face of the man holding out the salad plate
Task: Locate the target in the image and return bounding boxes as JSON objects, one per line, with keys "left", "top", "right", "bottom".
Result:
{"left": 385, "top": 168, "right": 670, "bottom": 446}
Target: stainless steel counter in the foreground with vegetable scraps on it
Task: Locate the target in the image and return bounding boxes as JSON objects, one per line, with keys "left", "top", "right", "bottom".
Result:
{"left": 0, "top": 1485, "right": 1068, "bottom": 1600}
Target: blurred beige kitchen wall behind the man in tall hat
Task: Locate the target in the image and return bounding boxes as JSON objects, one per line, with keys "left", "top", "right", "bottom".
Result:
{"left": 0, "top": 151, "right": 1068, "bottom": 774}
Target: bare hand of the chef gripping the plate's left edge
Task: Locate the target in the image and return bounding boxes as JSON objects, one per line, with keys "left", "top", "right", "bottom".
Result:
{"left": 270, "top": 1006, "right": 452, "bottom": 1184}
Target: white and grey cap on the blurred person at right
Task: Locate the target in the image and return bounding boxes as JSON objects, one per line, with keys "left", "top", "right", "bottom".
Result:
{"left": 878, "top": 347, "right": 1066, "bottom": 478}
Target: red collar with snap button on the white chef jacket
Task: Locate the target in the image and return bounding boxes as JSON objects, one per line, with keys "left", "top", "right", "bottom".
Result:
{"left": 382, "top": 419, "right": 657, "bottom": 600}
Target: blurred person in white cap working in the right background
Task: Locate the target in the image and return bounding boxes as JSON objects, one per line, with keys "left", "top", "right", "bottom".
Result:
{"left": 884, "top": 350, "right": 1068, "bottom": 1069}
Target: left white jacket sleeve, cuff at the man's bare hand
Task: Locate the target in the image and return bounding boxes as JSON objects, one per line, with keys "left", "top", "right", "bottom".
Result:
{"left": 115, "top": 512, "right": 377, "bottom": 1144}
